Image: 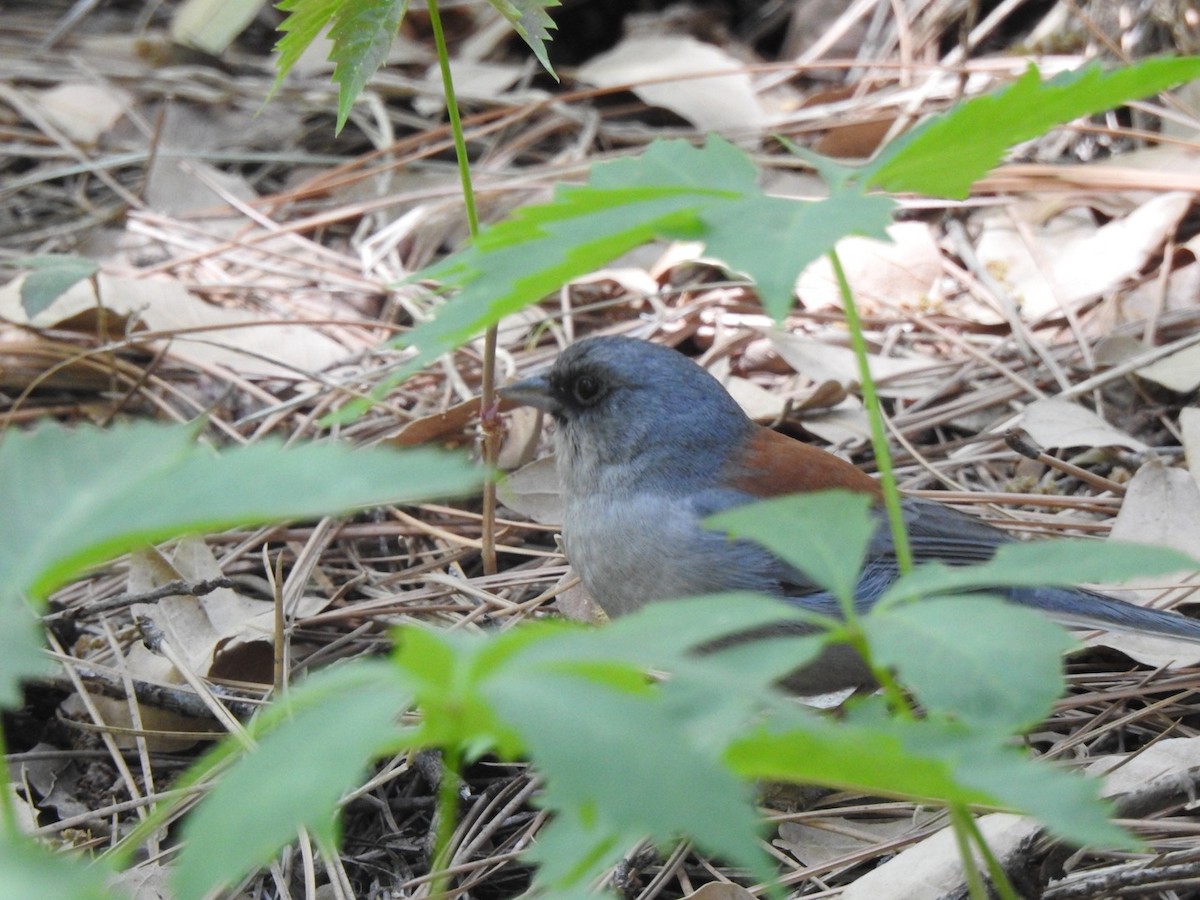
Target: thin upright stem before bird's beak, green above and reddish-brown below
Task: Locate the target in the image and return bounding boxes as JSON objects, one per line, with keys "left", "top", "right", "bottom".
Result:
{"left": 426, "top": 0, "right": 500, "bottom": 575}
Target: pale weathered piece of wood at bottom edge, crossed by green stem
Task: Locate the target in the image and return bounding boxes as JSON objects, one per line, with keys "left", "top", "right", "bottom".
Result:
{"left": 841, "top": 812, "right": 1042, "bottom": 900}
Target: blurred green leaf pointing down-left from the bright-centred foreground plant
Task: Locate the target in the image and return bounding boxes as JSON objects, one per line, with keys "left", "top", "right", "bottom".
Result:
{"left": 172, "top": 661, "right": 412, "bottom": 900}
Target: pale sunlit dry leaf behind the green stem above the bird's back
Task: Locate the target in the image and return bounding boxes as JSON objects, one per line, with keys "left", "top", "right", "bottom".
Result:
{"left": 796, "top": 222, "right": 942, "bottom": 310}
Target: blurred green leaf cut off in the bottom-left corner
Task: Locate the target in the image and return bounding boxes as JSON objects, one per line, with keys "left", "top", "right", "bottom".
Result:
{"left": 0, "top": 830, "right": 116, "bottom": 900}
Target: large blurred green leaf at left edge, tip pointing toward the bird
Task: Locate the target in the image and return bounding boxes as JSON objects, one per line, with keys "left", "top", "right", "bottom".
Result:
{"left": 0, "top": 422, "right": 482, "bottom": 701}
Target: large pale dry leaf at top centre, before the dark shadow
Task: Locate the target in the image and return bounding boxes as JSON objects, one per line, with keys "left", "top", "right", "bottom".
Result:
{"left": 577, "top": 34, "right": 769, "bottom": 132}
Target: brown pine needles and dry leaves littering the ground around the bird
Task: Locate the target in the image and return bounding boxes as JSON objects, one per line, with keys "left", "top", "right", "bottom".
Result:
{"left": 7, "top": 2, "right": 1200, "bottom": 898}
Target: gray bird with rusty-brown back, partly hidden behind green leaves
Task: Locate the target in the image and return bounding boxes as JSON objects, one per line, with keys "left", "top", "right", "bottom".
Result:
{"left": 500, "top": 336, "right": 1200, "bottom": 692}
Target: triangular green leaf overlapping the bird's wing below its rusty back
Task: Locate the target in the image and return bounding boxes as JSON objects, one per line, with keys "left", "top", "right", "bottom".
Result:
{"left": 706, "top": 491, "right": 876, "bottom": 604}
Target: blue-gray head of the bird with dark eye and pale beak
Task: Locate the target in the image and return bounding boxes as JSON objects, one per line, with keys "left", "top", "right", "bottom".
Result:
{"left": 500, "top": 337, "right": 752, "bottom": 492}
